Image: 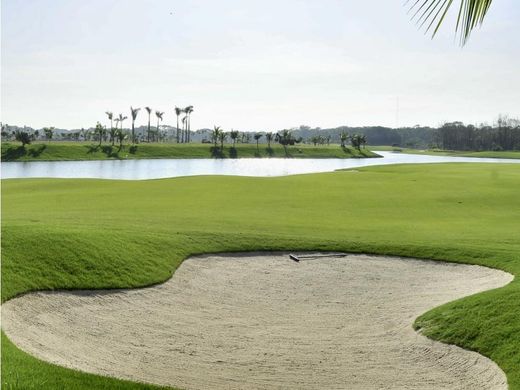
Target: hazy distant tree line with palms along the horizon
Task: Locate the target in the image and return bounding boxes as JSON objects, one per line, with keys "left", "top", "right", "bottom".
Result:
{"left": 2, "top": 115, "right": 520, "bottom": 151}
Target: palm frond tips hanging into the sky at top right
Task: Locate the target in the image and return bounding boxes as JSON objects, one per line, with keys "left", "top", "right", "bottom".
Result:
{"left": 407, "top": 0, "right": 492, "bottom": 46}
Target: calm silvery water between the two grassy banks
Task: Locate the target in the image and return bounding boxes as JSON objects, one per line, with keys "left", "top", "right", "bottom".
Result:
{"left": 1, "top": 152, "right": 520, "bottom": 180}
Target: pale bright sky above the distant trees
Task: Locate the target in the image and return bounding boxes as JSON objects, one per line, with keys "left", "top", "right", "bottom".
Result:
{"left": 1, "top": 0, "right": 520, "bottom": 131}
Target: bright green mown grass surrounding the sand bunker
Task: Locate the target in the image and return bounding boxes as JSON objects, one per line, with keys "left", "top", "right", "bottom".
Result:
{"left": 2, "top": 164, "right": 520, "bottom": 390}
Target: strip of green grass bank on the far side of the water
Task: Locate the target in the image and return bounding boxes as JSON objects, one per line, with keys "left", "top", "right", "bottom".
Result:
{"left": 2, "top": 142, "right": 379, "bottom": 161}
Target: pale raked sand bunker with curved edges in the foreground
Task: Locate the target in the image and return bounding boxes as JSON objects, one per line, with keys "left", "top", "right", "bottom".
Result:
{"left": 2, "top": 254, "right": 512, "bottom": 389}
